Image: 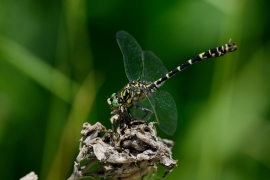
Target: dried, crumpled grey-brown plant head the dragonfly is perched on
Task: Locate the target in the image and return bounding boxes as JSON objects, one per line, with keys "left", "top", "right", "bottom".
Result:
{"left": 68, "top": 120, "right": 177, "bottom": 180}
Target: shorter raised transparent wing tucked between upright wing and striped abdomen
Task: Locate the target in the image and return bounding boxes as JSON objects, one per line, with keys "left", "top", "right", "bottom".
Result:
{"left": 141, "top": 51, "right": 168, "bottom": 82}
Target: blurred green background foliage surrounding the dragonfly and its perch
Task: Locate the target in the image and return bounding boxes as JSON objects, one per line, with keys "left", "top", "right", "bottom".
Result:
{"left": 0, "top": 0, "right": 270, "bottom": 180}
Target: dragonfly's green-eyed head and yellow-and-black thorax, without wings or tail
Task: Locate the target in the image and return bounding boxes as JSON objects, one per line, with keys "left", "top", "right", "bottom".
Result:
{"left": 107, "top": 81, "right": 157, "bottom": 109}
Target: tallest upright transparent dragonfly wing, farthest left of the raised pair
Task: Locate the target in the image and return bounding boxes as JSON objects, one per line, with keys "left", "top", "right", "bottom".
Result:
{"left": 116, "top": 31, "right": 143, "bottom": 81}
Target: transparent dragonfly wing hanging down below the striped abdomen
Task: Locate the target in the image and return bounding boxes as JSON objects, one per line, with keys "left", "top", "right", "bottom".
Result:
{"left": 148, "top": 90, "right": 177, "bottom": 135}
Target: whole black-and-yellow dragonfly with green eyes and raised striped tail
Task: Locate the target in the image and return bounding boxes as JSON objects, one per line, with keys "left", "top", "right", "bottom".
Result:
{"left": 107, "top": 31, "right": 237, "bottom": 135}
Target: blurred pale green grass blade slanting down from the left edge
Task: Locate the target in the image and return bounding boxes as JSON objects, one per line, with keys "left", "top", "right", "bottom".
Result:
{"left": 0, "top": 36, "right": 79, "bottom": 103}
